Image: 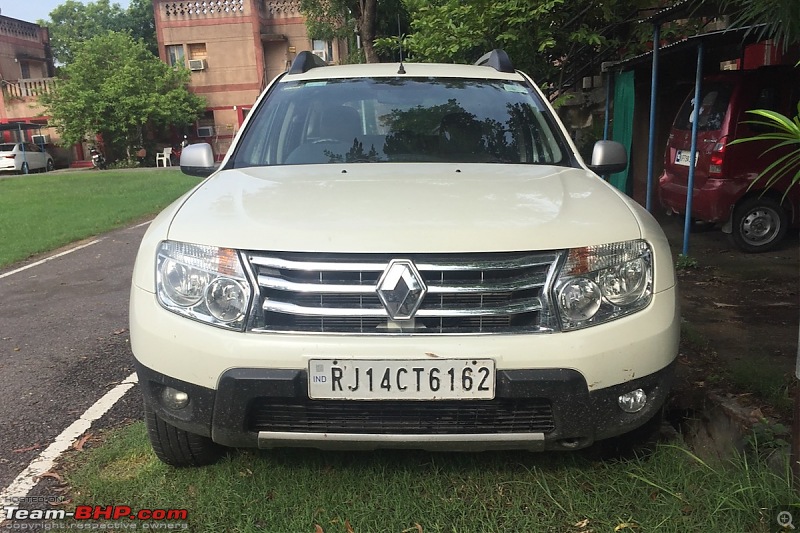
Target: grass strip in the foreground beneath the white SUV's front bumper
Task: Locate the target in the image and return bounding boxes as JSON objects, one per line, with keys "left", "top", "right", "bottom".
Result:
{"left": 59, "top": 422, "right": 796, "bottom": 533}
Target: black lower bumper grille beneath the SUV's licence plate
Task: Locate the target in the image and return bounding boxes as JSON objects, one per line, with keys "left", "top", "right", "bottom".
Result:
{"left": 247, "top": 398, "right": 555, "bottom": 435}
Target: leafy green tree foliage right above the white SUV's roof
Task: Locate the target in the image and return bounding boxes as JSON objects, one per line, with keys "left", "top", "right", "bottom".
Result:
{"left": 398, "top": 0, "right": 642, "bottom": 85}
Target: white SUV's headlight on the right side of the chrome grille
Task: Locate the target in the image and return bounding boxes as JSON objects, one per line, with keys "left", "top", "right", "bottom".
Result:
{"left": 554, "top": 240, "right": 653, "bottom": 330}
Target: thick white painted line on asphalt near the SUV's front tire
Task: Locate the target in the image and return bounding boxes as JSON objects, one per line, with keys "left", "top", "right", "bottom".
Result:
{"left": 0, "top": 372, "right": 138, "bottom": 510}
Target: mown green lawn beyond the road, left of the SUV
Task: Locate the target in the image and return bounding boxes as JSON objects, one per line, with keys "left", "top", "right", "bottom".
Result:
{"left": 0, "top": 169, "right": 199, "bottom": 267}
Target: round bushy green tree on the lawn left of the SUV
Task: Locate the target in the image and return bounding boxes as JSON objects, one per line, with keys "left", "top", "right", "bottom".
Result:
{"left": 40, "top": 32, "right": 205, "bottom": 160}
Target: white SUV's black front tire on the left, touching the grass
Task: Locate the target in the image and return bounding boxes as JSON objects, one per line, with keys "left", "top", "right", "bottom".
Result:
{"left": 144, "top": 404, "right": 225, "bottom": 467}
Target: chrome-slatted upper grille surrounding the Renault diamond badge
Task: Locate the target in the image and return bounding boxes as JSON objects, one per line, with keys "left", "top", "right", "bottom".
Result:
{"left": 247, "top": 251, "right": 561, "bottom": 334}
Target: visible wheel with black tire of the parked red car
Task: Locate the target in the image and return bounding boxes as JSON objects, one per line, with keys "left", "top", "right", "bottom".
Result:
{"left": 730, "top": 196, "right": 789, "bottom": 253}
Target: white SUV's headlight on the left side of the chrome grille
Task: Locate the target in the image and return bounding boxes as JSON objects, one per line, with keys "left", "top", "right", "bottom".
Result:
{"left": 156, "top": 241, "right": 252, "bottom": 330}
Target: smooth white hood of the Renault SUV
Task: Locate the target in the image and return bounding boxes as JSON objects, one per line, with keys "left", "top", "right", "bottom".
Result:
{"left": 168, "top": 163, "right": 641, "bottom": 253}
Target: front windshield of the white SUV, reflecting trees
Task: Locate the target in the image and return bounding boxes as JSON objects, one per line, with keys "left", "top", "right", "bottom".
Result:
{"left": 231, "top": 78, "right": 568, "bottom": 167}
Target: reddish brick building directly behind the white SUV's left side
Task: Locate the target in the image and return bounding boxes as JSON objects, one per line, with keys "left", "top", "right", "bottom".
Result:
{"left": 153, "top": 0, "right": 344, "bottom": 158}
